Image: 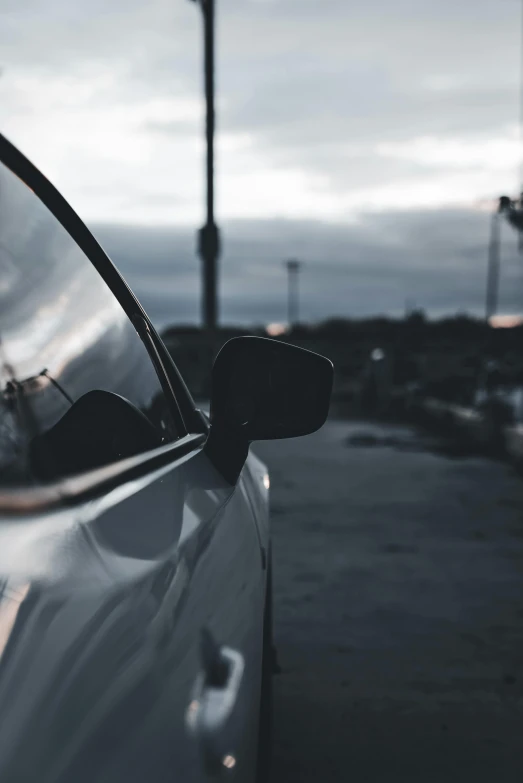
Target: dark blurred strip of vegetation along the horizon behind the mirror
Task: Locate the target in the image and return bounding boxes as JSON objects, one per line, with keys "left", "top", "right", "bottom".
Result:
{"left": 163, "top": 311, "right": 523, "bottom": 405}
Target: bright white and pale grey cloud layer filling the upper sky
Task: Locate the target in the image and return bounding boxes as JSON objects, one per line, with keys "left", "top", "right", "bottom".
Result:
{"left": 0, "top": 0, "right": 519, "bottom": 225}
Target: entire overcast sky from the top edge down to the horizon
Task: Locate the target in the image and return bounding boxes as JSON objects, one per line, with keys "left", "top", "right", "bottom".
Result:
{"left": 0, "top": 0, "right": 523, "bottom": 325}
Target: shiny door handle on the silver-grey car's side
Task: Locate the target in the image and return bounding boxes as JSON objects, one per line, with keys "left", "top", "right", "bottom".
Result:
{"left": 186, "top": 629, "right": 245, "bottom": 773}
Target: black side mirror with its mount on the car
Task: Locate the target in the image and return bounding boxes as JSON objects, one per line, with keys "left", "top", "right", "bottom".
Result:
{"left": 207, "top": 337, "right": 334, "bottom": 481}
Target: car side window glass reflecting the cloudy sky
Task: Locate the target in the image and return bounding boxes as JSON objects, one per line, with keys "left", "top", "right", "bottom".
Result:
{"left": 0, "top": 157, "right": 178, "bottom": 486}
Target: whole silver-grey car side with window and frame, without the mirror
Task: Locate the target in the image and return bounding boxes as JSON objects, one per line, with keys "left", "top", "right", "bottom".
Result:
{"left": 0, "top": 137, "right": 265, "bottom": 783}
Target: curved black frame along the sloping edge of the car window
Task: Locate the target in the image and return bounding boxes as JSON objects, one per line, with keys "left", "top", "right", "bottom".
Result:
{"left": 0, "top": 134, "right": 208, "bottom": 444}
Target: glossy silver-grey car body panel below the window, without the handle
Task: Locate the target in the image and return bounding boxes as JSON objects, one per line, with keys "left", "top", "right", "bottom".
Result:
{"left": 0, "top": 450, "right": 264, "bottom": 783}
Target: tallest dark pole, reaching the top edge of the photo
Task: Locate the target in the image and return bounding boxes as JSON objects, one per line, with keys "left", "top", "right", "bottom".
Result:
{"left": 188, "top": 0, "right": 220, "bottom": 331}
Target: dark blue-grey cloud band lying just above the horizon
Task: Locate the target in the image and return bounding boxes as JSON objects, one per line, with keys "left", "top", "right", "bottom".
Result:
{"left": 93, "top": 205, "right": 523, "bottom": 327}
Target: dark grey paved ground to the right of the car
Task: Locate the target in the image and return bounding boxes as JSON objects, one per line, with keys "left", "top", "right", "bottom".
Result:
{"left": 256, "top": 422, "right": 523, "bottom": 783}
